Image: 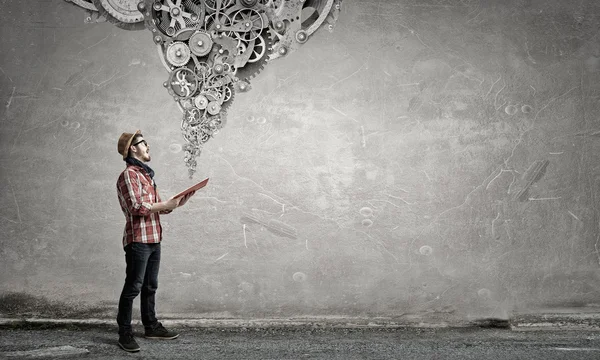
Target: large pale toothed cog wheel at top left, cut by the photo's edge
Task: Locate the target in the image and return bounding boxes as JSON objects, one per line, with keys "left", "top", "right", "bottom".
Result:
{"left": 88, "top": 0, "right": 144, "bottom": 30}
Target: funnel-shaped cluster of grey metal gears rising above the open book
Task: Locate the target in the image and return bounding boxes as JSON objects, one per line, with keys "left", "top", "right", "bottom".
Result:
{"left": 67, "top": 0, "right": 342, "bottom": 177}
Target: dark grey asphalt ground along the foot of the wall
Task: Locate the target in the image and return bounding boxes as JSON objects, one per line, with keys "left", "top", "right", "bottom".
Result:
{"left": 0, "top": 325, "right": 600, "bottom": 360}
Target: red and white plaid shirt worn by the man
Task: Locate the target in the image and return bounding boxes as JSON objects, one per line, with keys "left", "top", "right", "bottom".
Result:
{"left": 117, "top": 165, "right": 162, "bottom": 247}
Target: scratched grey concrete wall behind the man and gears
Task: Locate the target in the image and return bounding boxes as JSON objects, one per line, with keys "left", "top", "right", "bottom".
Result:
{"left": 0, "top": 0, "right": 600, "bottom": 322}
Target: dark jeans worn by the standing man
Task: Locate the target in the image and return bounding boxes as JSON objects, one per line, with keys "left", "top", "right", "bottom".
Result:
{"left": 117, "top": 242, "right": 160, "bottom": 335}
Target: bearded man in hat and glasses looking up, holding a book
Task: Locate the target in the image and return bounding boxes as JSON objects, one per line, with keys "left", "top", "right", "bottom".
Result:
{"left": 117, "top": 130, "right": 194, "bottom": 352}
